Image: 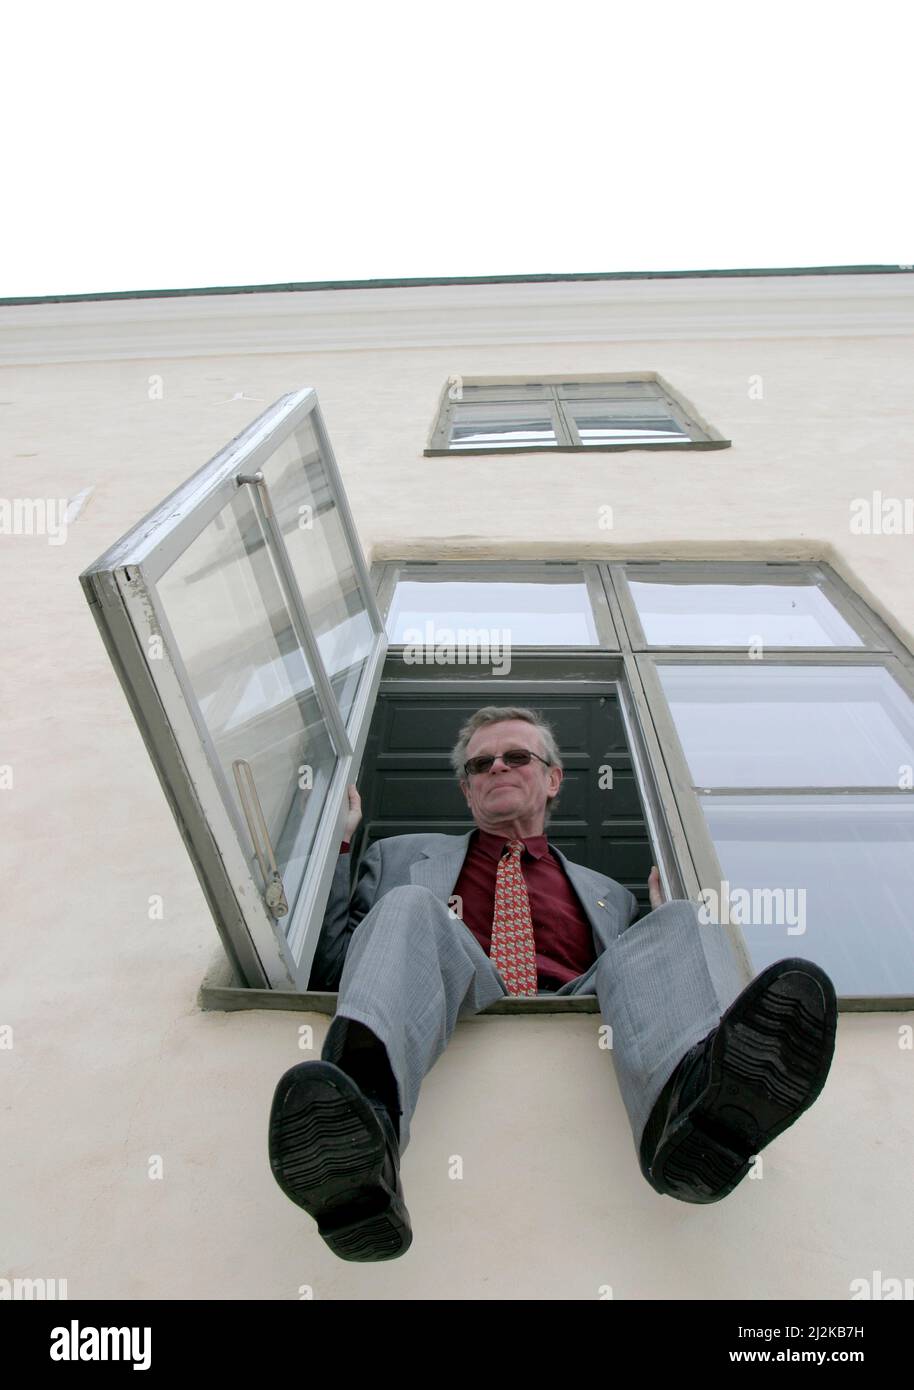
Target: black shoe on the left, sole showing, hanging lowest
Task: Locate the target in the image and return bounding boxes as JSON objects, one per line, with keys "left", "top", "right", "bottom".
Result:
{"left": 269, "top": 1061, "right": 413, "bottom": 1261}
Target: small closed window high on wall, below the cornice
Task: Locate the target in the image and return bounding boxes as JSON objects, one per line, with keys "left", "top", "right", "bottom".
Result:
{"left": 425, "top": 373, "right": 729, "bottom": 455}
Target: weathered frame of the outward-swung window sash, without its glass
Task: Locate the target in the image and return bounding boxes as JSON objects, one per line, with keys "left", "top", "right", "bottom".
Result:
{"left": 79, "top": 388, "right": 388, "bottom": 991}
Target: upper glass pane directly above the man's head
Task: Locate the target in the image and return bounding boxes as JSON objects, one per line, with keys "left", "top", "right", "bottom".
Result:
{"left": 388, "top": 578, "right": 599, "bottom": 646}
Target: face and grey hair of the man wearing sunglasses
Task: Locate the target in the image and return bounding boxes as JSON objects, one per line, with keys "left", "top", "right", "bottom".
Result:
{"left": 461, "top": 719, "right": 563, "bottom": 835}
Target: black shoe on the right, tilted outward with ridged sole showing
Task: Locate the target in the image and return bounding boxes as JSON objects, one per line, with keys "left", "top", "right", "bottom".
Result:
{"left": 640, "top": 958, "right": 838, "bottom": 1202}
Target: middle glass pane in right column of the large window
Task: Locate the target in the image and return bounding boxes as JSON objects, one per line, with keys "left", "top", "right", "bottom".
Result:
{"left": 657, "top": 662, "right": 914, "bottom": 787}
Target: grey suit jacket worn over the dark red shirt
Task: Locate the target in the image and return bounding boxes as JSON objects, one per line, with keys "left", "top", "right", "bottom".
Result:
{"left": 308, "top": 827, "right": 640, "bottom": 994}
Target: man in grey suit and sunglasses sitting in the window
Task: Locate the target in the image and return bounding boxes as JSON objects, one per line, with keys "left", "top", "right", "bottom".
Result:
{"left": 263, "top": 705, "right": 838, "bottom": 1261}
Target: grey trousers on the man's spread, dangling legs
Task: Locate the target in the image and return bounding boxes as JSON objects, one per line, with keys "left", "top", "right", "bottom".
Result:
{"left": 321, "top": 884, "right": 739, "bottom": 1152}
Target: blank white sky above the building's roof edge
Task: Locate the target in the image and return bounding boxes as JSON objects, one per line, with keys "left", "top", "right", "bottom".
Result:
{"left": 0, "top": 0, "right": 914, "bottom": 296}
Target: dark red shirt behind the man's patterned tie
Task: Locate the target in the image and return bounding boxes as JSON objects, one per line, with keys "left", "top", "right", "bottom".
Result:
{"left": 340, "top": 827, "right": 596, "bottom": 990}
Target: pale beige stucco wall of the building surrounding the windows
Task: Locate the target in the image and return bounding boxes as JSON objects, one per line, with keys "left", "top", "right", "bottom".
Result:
{"left": 0, "top": 277, "right": 914, "bottom": 1300}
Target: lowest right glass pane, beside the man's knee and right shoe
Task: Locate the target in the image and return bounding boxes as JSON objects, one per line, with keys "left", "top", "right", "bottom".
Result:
{"left": 699, "top": 795, "right": 914, "bottom": 995}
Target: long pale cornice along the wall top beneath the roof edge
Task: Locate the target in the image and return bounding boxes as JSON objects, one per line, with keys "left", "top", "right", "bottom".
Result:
{"left": 0, "top": 270, "right": 914, "bottom": 366}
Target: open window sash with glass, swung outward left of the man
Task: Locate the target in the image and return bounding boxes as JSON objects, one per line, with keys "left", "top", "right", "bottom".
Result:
{"left": 79, "top": 388, "right": 386, "bottom": 990}
